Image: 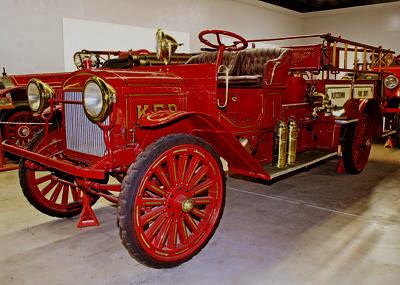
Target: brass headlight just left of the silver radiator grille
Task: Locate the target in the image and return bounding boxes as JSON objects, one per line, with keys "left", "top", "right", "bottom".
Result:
{"left": 27, "top": 78, "right": 54, "bottom": 114}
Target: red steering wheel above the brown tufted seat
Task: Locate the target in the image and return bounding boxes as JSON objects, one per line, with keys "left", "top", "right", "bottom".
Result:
{"left": 199, "top": 30, "right": 249, "bottom": 51}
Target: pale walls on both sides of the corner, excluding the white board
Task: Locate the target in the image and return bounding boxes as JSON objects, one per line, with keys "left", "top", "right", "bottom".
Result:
{"left": 0, "top": 0, "right": 400, "bottom": 73}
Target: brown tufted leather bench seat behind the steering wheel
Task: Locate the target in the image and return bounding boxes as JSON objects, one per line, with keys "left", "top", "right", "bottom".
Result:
{"left": 186, "top": 48, "right": 287, "bottom": 87}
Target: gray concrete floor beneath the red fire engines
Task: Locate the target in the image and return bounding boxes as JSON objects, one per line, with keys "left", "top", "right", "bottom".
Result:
{"left": 0, "top": 145, "right": 400, "bottom": 285}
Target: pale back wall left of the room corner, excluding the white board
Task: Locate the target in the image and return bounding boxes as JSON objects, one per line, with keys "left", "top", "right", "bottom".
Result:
{"left": 0, "top": 0, "right": 303, "bottom": 73}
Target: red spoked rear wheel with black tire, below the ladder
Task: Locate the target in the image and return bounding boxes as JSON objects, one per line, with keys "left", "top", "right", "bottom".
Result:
{"left": 343, "top": 114, "right": 372, "bottom": 174}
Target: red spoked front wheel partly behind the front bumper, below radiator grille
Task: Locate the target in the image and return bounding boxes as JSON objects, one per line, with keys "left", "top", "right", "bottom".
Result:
{"left": 19, "top": 127, "right": 98, "bottom": 218}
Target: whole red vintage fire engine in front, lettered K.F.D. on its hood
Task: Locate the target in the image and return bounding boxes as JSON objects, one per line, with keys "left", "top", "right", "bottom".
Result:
{"left": 3, "top": 30, "right": 392, "bottom": 268}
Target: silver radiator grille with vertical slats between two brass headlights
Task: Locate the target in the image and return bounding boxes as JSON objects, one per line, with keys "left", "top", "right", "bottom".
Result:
{"left": 64, "top": 92, "right": 106, "bottom": 157}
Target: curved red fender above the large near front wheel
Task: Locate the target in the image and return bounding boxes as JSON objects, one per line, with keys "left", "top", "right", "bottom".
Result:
{"left": 136, "top": 111, "right": 270, "bottom": 180}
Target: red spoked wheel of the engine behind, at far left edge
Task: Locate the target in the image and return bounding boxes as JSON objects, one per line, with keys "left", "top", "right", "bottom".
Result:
{"left": 3, "top": 110, "right": 42, "bottom": 148}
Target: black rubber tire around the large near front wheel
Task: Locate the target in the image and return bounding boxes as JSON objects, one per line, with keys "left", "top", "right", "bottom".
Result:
{"left": 117, "top": 134, "right": 226, "bottom": 268}
